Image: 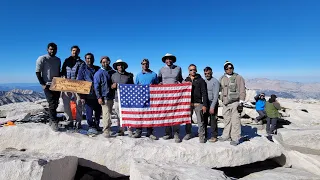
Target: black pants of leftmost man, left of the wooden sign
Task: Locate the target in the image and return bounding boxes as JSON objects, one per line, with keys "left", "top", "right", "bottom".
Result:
{"left": 43, "top": 87, "right": 60, "bottom": 122}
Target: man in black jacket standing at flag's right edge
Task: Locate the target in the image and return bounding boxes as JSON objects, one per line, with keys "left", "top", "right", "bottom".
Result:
{"left": 183, "top": 64, "right": 208, "bottom": 143}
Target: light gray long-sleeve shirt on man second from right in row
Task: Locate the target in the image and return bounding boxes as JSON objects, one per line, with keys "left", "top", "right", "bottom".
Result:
{"left": 204, "top": 77, "right": 220, "bottom": 108}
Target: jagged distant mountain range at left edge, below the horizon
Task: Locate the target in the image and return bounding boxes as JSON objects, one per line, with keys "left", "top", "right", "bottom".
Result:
{"left": 0, "top": 89, "right": 45, "bottom": 106}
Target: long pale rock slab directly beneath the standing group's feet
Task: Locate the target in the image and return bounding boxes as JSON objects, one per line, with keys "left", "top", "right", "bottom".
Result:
{"left": 0, "top": 123, "right": 282, "bottom": 177}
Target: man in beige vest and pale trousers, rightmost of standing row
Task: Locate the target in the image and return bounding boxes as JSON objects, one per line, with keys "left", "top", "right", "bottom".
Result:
{"left": 219, "top": 61, "right": 246, "bottom": 145}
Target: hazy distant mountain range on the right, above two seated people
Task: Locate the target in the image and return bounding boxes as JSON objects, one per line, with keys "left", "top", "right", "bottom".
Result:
{"left": 246, "top": 78, "right": 320, "bottom": 100}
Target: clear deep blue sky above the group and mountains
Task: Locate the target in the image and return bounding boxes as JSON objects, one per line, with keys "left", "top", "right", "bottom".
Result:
{"left": 0, "top": 0, "right": 320, "bottom": 83}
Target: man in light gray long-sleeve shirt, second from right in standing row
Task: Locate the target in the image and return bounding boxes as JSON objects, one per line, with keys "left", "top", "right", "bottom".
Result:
{"left": 203, "top": 67, "right": 220, "bottom": 142}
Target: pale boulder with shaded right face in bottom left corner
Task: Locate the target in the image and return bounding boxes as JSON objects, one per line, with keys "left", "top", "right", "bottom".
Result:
{"left": 0, "top": 149, "right": 78, "bottom": 180}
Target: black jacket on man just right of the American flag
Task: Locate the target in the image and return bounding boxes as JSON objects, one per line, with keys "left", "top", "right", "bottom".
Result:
{"left": 185, "top": 74, "right": 209, "bottom": 107}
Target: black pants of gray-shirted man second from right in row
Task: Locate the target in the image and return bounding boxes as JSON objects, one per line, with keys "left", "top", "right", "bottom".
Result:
{"left": 203, "top": 103, "right": 218, "bottom": 138}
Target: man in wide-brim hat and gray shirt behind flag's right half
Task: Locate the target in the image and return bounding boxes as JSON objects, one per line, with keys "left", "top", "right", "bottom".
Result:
{"left": 158, "top": 53, "right": 183, "bottom": 143}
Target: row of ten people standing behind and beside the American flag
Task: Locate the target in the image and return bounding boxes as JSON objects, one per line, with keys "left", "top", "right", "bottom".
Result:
{"left": 36, "top": 43, "right": 280, "bottom": 145}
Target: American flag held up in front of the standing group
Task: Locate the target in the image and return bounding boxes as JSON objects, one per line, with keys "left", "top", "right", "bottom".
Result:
{"left": 118, "top": 83, "right": 192, "bottom": 127}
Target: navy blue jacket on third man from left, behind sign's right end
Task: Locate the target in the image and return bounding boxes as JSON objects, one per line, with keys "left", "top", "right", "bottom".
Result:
{"left": 77, "top": 64, "right": 100, "bottom": 99}
